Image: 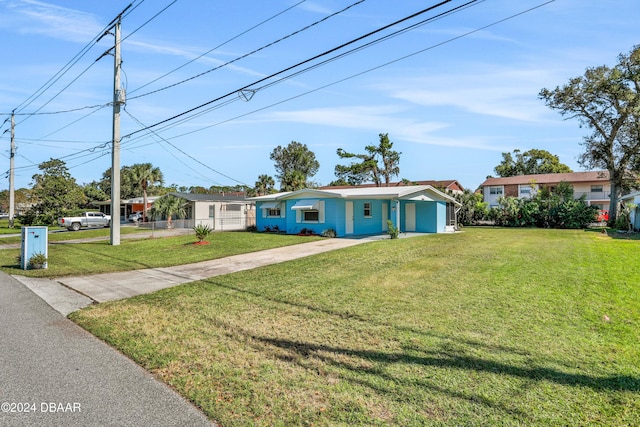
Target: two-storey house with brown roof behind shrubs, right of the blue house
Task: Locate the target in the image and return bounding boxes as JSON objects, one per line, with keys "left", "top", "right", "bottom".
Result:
{"left": 480, "top": 171, "right": 611, "bottom": 210}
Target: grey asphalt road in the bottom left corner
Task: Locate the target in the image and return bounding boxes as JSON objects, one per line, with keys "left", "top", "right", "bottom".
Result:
{"left": 0, "top": 272, "right": 213, "bottom": 427}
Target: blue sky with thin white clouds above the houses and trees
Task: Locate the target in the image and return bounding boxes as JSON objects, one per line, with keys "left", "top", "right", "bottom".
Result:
{"left": 0, "top": 0, "right": 640, "bottom": 190}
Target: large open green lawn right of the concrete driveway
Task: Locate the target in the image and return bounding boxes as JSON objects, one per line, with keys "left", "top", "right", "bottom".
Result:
{"left": 71, "top": 228, "right": 640, "bottom": 426}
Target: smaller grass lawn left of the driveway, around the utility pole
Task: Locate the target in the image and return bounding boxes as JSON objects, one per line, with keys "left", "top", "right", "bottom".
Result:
{"left": 0, "top": 232, "right": 319, "bottom": 277}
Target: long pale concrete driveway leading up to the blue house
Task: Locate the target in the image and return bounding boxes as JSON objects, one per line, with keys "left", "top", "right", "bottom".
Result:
{"left": 13, "top": 236, "right": 381, "bottom": 316}
